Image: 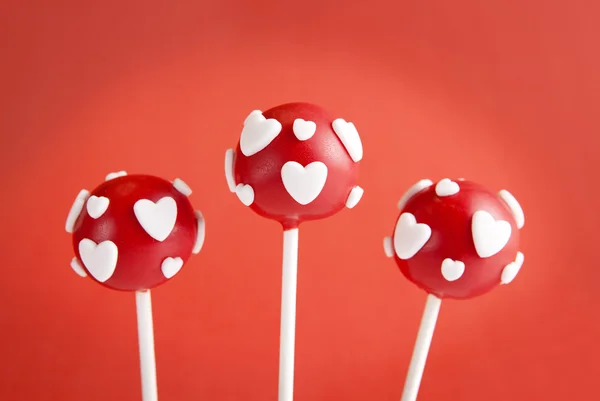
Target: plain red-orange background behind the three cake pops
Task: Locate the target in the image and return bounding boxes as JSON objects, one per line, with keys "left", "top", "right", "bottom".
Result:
{"left": 0, "top": 0, "right": 600, "bottom": 401}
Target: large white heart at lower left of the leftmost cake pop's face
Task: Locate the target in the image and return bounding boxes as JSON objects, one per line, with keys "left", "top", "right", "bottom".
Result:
{"left": 79, "top": 238, "right": 119, "bottom": 283}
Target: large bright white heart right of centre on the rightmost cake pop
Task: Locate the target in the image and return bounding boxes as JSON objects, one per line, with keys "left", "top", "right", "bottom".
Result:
{"left": 471, "top": 210, "right": 511, "bottom": 258}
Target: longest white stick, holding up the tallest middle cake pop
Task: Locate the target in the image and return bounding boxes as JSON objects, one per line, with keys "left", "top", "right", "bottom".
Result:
{"left": 279, "top": 228, "right": 298, "bottom": 401}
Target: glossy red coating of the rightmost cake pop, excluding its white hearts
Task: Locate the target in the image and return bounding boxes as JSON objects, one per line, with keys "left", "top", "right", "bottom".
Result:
{"left": 394, "top": 181, "right": 519, "bottom": 299}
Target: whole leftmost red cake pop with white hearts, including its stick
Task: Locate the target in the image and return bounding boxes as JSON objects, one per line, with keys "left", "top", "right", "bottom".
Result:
{"left": 66, "top": 171, "right": 204, "bottom": 401}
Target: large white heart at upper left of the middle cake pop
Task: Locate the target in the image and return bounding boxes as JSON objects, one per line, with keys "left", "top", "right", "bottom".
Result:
{"left": 240, "top": 110, "right": 281, "bottom": 157}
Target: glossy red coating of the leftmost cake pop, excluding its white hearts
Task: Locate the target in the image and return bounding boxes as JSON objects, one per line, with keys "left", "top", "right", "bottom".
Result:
{"left": 73, "top": 175, "right": 197, "bottom": 291}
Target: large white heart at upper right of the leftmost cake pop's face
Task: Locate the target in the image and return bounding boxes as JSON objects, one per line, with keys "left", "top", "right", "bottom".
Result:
{"left": 133, "top": 196, "right": 177, "bottom": 242}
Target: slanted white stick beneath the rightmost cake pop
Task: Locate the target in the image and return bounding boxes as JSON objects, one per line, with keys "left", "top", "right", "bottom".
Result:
{"left": 401, "top": 294, "right": 442, "bottom": 401}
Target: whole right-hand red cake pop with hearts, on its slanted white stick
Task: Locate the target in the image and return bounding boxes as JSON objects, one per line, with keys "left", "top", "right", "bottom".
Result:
{"left": 384, "top": 178, "right": 525, "bottom": 401}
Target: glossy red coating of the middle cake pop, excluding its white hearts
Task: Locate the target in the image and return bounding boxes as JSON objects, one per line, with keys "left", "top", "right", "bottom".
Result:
{"left": 234, "top": 103, "right": 360, "bottom": 229}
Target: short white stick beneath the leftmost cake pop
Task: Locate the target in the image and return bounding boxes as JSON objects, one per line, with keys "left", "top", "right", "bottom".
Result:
{"left": 135, "top": 290, "right": 158, "bottom": 401}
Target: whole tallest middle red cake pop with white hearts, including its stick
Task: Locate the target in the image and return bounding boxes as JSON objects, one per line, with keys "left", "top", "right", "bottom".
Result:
{"left": 225, "top": 103, "right": 363, "bottom": 401}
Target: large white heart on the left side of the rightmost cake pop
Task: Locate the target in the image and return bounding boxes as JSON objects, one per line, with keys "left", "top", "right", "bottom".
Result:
{"left": 394, "top": 213, "right": 431, "bottom": 260}
